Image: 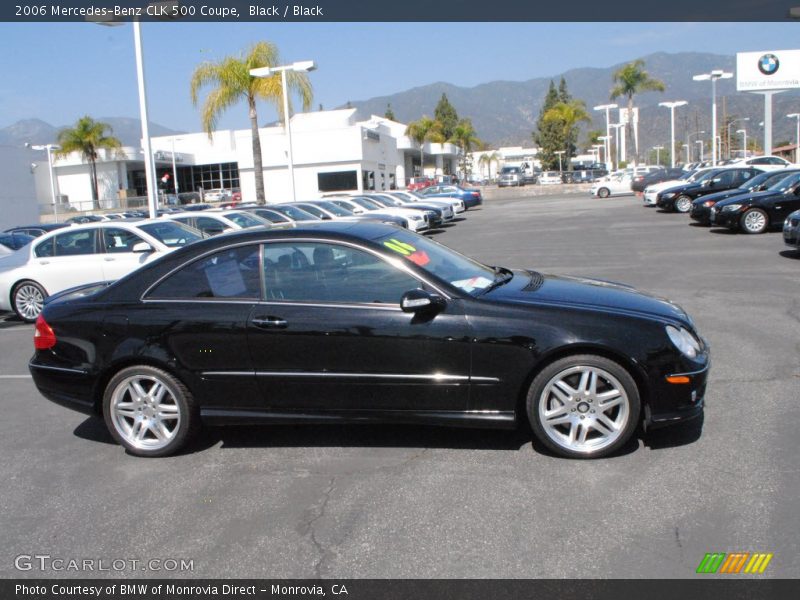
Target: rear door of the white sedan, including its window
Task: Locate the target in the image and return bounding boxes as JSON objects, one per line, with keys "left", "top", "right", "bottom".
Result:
{"left": 28, "top": 227, "right": 104, "bottom": 294}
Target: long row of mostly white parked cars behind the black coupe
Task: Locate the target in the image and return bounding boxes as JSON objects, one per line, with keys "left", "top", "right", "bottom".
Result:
{"left": 0, "top": 185, "right": 483, "bottom": 322}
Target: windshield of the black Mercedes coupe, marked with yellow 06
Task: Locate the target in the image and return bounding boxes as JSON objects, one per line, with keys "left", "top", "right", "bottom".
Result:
{"left": 376, "top": 230, "right": 497, "bottom": 296}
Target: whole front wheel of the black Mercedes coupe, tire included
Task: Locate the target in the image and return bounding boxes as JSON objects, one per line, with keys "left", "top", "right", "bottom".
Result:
{"left": 526, "top": 354, "right": 641, "bottom": 458}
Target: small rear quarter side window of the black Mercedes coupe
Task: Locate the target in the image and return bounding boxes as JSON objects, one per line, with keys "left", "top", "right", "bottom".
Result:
{"left": 148, "top": 245, "right": 261, "bottom": 300}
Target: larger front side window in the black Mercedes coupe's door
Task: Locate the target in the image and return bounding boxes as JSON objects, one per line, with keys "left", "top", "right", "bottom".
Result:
{"left": 264, "top": 243, "right": 420, "bottom": 305}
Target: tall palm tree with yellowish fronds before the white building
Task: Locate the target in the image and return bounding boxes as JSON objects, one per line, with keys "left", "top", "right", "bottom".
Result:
{"left": 191, "top": 42, "right": 313, "bottom": 204}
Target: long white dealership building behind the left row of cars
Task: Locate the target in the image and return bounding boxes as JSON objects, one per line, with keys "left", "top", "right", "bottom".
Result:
{"left": 34, "top": 109, "right": 459, "bottom": 213}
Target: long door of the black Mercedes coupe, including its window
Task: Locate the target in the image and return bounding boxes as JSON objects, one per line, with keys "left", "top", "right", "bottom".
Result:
{"left": 248, "top": 241, "right": 470, "bottom": 411}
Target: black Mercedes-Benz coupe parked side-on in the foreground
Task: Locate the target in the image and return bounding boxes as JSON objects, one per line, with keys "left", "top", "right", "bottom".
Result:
{"left": 30, "top": 222, "right": 709, "bottom": 458}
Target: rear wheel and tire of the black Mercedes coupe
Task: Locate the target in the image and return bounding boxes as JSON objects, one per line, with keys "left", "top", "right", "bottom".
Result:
{"left": 103, "top": 365, "right": 200, "bottom": 457}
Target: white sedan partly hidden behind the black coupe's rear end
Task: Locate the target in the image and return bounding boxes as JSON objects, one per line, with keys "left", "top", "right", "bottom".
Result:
{"left": 0, "top": 219, "right": 202, "bottom": 323}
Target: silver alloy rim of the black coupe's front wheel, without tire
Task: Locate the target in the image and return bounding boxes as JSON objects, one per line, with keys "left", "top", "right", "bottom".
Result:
{"left": 538, "top": 365, "right": 630, "bottom": 455}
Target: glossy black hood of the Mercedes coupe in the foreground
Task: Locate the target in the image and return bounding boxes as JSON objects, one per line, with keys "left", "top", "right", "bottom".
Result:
{"left": 485, "top": 270, "right": 692, "bottom": 326}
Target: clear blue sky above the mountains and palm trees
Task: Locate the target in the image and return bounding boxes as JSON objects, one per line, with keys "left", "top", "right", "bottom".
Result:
{"left": 0, "top": 22, "right": 800, "bottom": 131}
